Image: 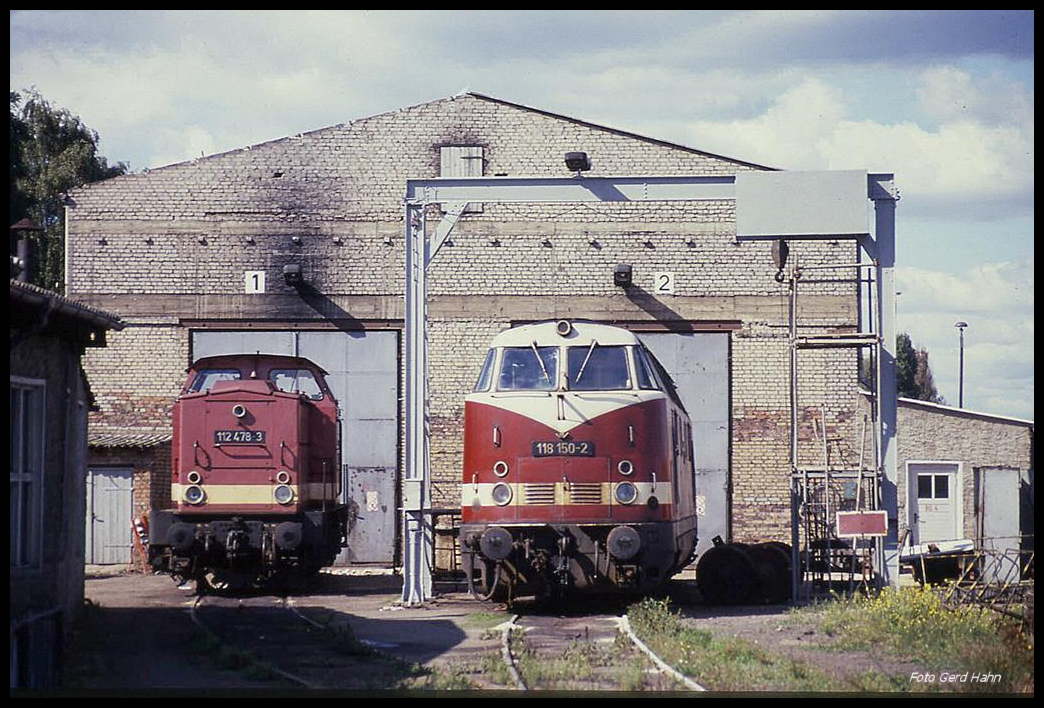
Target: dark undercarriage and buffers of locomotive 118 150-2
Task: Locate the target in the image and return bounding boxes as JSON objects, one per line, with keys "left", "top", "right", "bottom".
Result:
{"left": 460, "top": 522, "right": 694, "bottom": 601}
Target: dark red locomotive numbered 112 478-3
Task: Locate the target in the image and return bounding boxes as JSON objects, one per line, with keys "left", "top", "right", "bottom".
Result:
{"left": 149, "top": 354, "right": 350, "bottom": 589}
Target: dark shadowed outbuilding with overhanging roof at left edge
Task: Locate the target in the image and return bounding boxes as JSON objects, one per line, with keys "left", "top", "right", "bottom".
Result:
{"left": 8, "top": 280, "right": 123, "bottom": 689}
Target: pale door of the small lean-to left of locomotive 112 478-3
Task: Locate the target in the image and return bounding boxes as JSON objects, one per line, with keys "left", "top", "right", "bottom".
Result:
{"left": 85, "top": 467, "right": 134, "bottom": 565}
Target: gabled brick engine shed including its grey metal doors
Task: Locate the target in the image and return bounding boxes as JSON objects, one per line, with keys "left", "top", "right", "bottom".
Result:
{"left": 67, "top": 93, "right": 861, "bottom": 567}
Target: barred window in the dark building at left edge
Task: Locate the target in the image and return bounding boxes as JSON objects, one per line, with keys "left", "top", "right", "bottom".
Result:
{"left": 9, "top": 377, "right": 44, "bottom": 568}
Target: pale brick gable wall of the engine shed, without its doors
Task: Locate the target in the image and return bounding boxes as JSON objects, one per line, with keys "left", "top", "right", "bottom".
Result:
{"left": 68, "top": 95, "right": 857, "bottom": 539}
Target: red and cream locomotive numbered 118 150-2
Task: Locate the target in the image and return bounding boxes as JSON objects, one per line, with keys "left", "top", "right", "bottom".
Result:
{"left": 460, "top": 321, "right": 696, "bottom": 599}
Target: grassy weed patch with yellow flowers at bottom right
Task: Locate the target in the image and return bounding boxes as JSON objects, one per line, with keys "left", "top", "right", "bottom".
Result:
{"left": 794, "top": 587, "right": 1034, "bottom": 692}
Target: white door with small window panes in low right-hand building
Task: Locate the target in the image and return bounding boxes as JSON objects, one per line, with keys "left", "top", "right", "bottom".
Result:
{"left": 909, "top": 463, "right": 960, "bottom": 544}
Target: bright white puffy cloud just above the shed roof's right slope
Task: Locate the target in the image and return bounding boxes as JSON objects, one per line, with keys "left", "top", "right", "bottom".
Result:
{"left": 663, "top": 73, "right": 1034, "bottom": 219}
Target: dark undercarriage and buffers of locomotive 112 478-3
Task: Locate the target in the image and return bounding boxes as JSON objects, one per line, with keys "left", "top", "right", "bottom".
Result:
{"left": 149, "top": 508, "right": 348, "bottom": 591}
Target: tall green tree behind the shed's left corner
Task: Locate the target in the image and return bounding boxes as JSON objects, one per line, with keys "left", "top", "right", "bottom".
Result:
{"left": 10, "top": 89, "right": 128, "bottom": 291}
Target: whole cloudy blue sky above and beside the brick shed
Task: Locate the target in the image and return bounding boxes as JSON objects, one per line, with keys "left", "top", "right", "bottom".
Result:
{"left": 10, "top": 10, "right": 1034, "bottom": 419}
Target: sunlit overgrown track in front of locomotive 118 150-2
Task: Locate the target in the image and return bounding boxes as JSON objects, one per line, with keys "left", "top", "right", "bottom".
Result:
{"left": 501, "top": 613, "right": 704, "bottom": 691}
